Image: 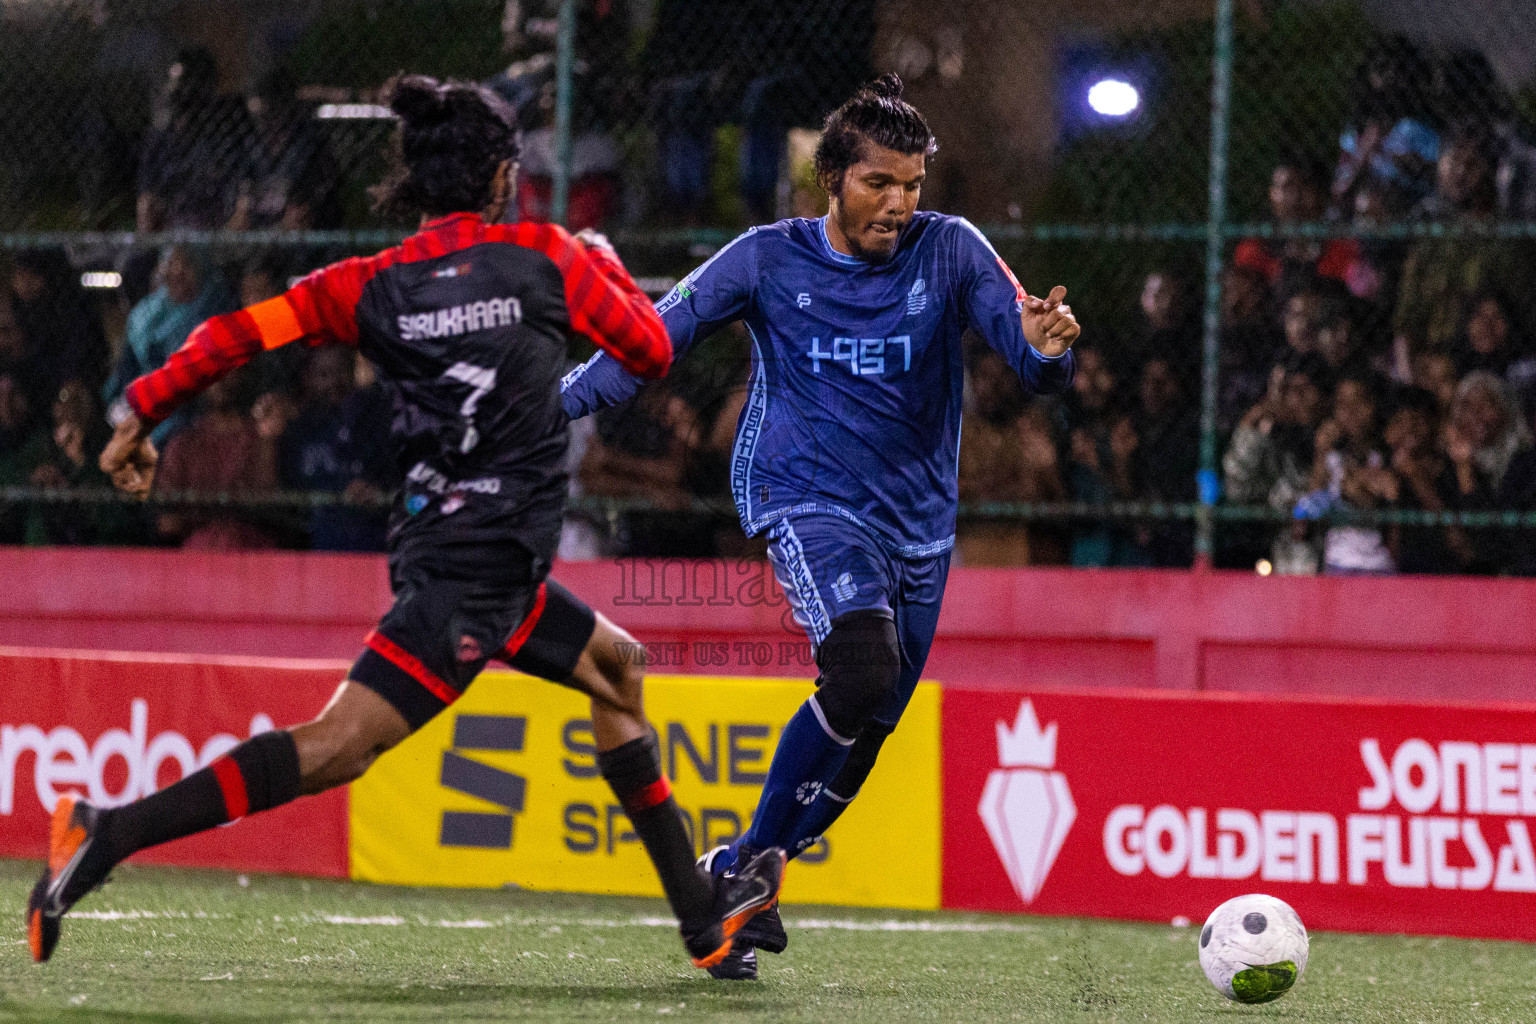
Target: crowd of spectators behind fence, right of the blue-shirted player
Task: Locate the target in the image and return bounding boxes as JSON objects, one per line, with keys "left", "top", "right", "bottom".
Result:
{"left": 933, "top": 38, "right": 1536, "bottom": 574}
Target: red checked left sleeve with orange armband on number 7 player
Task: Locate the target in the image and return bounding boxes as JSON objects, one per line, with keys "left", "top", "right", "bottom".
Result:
{"left": 124, "top": 257, "right": 393, "bottom": 424}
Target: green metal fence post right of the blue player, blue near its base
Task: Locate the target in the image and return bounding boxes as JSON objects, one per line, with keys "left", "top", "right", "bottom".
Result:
{"left": 1195, "top": 0, "right": 1232, "bottom": 568}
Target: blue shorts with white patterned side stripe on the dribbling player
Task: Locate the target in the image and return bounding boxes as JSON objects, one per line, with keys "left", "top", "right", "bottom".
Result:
{"left": 768, "top": 514, "right": 949, "bottom": 728}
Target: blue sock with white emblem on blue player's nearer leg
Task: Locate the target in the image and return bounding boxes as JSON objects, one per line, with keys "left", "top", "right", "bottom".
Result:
{"left": 736, "top": 694, "right": 852, "bottom": 854}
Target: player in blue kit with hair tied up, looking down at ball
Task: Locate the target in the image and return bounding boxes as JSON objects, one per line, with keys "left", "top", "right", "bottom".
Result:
{"left": 562, "top": 75, "right": 1080, "bottom": 978}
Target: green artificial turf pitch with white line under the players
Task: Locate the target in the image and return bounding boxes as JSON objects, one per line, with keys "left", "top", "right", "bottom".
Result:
{"left": 0, "top": 861, "right": 1536, "bottom": 1024}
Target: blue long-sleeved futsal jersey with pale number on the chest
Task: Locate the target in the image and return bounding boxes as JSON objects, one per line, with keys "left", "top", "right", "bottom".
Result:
{"left": 561, "top": 212, "right": 1074, "bottom": 557}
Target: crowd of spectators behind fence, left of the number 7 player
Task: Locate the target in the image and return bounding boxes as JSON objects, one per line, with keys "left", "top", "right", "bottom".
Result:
{"left": 0, "top": 40, "right": 398, "bottom": 551}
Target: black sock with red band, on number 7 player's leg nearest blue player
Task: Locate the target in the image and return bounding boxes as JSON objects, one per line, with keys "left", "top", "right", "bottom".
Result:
{"left": 598, "top": 732, "right": 714, "bottom": 926}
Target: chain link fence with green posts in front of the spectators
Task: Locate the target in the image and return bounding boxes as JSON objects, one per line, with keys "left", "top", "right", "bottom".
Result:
{"left": 0, "top": 0, "right": 1536, "bottom": 573}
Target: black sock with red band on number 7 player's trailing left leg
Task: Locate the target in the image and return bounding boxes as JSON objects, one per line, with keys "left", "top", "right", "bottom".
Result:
{"left": 100, "top": 731, "right": 300, "bottom": 864}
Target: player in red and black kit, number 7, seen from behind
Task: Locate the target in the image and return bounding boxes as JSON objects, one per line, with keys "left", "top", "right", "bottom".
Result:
{"left": 26, "top": 75, "right": 783, "bottom": 967}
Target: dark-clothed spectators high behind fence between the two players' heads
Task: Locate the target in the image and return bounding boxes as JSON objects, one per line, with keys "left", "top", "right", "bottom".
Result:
{"left": 488, "top": 0, "right": 876, "bottom": 229}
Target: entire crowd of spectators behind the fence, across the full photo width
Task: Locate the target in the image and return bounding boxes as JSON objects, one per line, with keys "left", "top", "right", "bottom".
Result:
{"left": 0, "top": 32, "right": 1536, "bottom": 573}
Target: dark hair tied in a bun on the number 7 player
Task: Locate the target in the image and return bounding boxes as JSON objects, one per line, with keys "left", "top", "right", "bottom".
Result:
{"left": 370, "top": 75, "right": 522, "bottom": 220}
